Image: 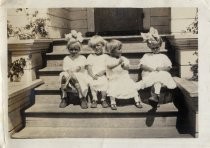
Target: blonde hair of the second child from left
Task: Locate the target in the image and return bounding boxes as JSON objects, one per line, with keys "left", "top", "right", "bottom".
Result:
{"left": 88, "top": 35, "right": 107, "bottom": 48}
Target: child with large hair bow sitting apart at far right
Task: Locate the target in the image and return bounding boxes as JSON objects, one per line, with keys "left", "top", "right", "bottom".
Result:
{"left": 137, "top": 27, "right": 176, "bottom": 104}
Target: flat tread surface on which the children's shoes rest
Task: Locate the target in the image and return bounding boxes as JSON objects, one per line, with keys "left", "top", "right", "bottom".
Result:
{"left": 25, "top": 103, "right": 178, "bottom": 114}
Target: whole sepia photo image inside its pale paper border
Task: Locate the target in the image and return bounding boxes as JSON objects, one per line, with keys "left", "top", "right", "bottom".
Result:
{"left": 7, "top": 7, "right": 199, "bottom": 139}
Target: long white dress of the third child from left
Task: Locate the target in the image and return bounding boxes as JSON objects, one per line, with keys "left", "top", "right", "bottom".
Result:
{"left": 107, "top": 57, "right": 138, "bottom": 99}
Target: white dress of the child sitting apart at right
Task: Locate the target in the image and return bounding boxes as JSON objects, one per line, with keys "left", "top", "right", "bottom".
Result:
{"left": 140, "top": 53, "right": 176, "bottom": 89}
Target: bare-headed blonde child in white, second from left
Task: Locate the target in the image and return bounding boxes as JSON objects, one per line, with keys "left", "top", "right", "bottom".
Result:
{"left": 87, "top": 35, "right": 108, "bottom": 108}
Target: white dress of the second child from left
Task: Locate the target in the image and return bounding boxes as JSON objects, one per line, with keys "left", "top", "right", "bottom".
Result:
{"left": 87, "top": 54, "right": 108, "bottom": 91}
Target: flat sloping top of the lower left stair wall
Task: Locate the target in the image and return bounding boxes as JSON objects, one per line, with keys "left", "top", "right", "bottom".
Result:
{"left": 8, "top": 79, "right": 44, "bottom": 98}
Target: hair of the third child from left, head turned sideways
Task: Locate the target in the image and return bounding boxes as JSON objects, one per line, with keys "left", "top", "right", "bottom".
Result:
{"left": 106, "top": 40, "right": 122, "bottom": 54}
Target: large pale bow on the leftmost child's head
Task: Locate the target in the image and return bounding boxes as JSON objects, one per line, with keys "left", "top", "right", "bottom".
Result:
{"left": 65, "top": 30, "right": 83, "bottom": 43}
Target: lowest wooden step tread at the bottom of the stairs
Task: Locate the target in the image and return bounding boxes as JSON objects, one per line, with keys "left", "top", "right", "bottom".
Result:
{"left": 12, "top": 127, "right": 193, "bottom": 139}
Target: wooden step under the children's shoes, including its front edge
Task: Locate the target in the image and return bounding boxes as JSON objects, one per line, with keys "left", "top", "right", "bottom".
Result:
{"left": 25, "top": 103, "right": 178, "bottom": 114}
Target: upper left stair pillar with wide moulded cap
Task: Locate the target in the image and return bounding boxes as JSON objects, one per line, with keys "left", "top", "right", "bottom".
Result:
{"left": 8, "top": 39, "right": 52, "bottom": 82}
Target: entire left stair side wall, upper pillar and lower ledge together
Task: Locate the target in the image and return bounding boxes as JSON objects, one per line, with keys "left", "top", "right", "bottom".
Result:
{"left": 8, "top": 39, "right": 52, "bottom": 134}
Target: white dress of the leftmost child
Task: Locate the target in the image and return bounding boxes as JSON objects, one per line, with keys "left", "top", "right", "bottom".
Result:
{"left": 60, "top": 55, "right": 88, "bottom": 95}
